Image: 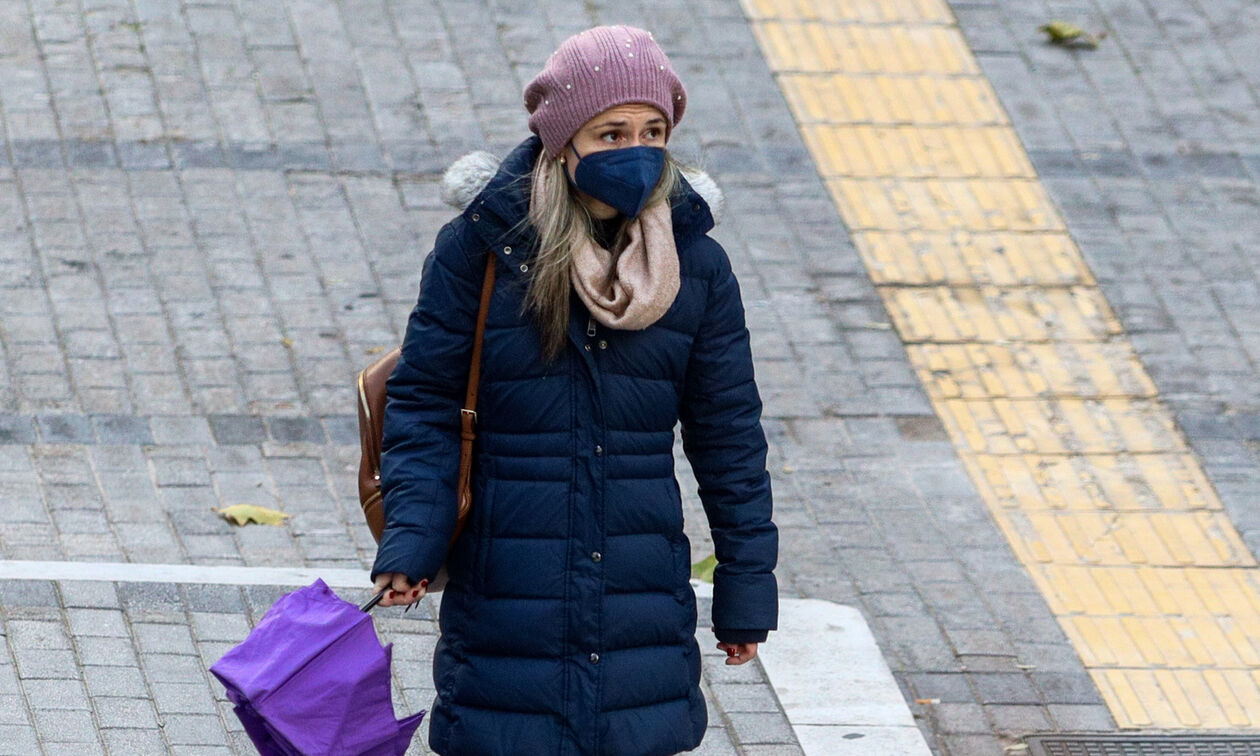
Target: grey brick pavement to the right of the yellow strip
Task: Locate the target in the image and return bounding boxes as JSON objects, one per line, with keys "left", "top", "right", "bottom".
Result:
{"left": 953, "top": 0, "right": 1260, "bottom": 554}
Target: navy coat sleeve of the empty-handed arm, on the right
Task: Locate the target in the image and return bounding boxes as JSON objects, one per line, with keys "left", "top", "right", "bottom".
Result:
{"left": 679, "top": 241, "right": 779, "bottom": 643}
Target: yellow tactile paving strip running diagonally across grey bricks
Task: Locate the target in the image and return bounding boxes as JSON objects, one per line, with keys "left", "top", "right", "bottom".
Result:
{"left": 742, "top": 0, "right": 1260, "bottom": 728}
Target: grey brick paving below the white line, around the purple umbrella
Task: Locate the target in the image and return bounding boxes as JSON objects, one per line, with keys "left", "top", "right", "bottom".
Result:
{"left": 0, "top": 581, "right": 786, "bottom": 756}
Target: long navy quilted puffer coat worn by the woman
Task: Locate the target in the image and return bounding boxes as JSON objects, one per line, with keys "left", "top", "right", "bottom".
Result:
{"left": 373, "top": 136, "right": 777, "bottom": 756}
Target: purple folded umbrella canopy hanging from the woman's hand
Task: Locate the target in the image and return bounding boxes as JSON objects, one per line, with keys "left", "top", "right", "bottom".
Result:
{"left": 210, "top": 580, "right": 425, "bottom": 756}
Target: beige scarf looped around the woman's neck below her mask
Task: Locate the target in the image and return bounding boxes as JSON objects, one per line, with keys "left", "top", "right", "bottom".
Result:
{"left": 529, "top": 163, "right": 679, "bottom": 330}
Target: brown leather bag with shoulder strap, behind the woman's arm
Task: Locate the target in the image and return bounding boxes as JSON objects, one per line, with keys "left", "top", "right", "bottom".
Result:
{"left": 358, "top": 255, "right": 494, "bottom": 593}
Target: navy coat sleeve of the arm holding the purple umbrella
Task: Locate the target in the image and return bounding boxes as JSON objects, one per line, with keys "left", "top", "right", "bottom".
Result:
{"left": 372, "top": 219, "right": 484, "bottom": 583}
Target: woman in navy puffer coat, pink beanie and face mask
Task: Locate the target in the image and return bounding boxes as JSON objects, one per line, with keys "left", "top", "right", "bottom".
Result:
{"left": 372, "top": 26, "right": 777, "bottom": 756}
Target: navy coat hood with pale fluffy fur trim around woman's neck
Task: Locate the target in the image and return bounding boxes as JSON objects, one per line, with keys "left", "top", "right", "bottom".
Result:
{"left": 441, "top": 135, "right": 725, "bottom": 267}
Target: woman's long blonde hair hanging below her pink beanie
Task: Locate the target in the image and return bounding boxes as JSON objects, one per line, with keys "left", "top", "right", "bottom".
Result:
{"left": 524, "top": 150, "right": 683, "bottom": 362}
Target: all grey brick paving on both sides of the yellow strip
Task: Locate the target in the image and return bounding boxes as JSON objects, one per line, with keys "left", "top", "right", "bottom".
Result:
{"left": 0, "top": 0, "right": 1260, "bottom": 756}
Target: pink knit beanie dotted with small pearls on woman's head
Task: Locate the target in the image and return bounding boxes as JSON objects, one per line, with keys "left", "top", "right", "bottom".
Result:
{"left": 525, "top": 26, "right": 687, "bottom": 158}
